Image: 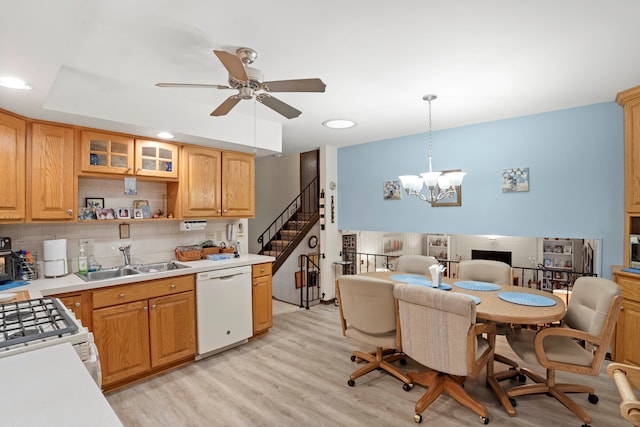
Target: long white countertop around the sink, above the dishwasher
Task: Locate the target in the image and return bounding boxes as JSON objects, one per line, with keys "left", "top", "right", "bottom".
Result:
{"left": 10, "top": 254, "right": 275, "bottom": 298}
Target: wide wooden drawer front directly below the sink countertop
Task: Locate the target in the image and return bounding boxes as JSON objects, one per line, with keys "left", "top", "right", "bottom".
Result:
{"left": 93, "top": 275, "right": 195, "bottom": 308}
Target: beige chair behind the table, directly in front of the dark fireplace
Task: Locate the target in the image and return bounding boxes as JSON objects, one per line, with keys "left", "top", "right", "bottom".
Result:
{"left": 457, "top": 259, "right": 526, "bottom": 382}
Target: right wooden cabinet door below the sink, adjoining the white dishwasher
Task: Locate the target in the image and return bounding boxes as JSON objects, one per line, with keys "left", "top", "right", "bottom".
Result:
{"left": 149, "top": 291, "right": 196, "bottom": 368}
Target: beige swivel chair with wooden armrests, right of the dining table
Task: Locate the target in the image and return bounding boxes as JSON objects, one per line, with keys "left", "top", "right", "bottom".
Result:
{"left": 507, "top": 277, "right": 622, "bottom": 425}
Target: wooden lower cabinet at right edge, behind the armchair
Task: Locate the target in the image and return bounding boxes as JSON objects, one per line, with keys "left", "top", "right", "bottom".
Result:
{"left": 613, "top": 270, "right": 640, "bottom": 366}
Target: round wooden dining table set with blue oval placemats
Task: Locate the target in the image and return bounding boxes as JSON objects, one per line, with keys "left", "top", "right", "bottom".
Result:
{"left": 361, "top": 271, "right": 566, "bottom": 416}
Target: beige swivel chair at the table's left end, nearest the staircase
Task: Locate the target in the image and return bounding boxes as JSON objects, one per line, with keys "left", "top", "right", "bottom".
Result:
{"left": 336, "top": 275, "right": 412, "bottom": 390}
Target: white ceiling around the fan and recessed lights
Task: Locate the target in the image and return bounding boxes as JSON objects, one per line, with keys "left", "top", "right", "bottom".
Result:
{"left": 0, "top": 0, "right": 640, "bottom": 155}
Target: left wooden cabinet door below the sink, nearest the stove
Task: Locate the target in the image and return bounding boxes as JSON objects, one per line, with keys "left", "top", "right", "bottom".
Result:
{"left": 92, "top": 300, "right": 149, "bottom": 386}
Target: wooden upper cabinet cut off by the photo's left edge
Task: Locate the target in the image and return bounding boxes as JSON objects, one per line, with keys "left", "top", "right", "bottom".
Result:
{"left": 0, "top": 112, "right": 27, "bottom": 221}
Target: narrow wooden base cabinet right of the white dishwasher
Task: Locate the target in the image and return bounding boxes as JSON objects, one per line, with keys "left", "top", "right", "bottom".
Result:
{"left": 251, "top": 262, "right": 273, "bottom": 337}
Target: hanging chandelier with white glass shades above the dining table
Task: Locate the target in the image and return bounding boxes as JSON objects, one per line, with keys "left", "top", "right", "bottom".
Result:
{"left": 398, "top": 95, "right": 466, "bottom": 206}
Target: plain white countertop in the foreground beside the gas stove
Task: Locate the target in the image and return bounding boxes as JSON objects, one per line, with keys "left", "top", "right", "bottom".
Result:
{"left": 0, "top": 343, "right": 122, "bottom": 427}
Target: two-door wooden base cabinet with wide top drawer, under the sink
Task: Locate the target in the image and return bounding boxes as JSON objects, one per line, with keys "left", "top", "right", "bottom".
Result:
{"left": 92, "top": 275, "right": 196, "bottom": 389}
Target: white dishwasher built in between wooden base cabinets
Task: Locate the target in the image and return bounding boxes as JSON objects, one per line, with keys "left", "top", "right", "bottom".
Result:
{"left": 196, "top": 266, "right": 253, "bottom": 360}
